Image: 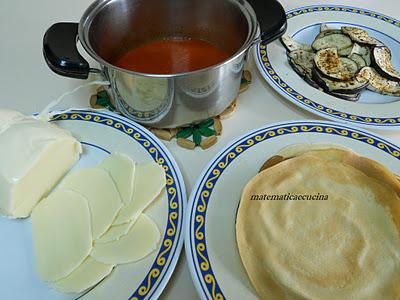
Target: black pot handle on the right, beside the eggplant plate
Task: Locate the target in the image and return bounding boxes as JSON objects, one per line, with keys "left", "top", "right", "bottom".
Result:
{"left": 247, "top": 0, "right": 287, "bottom": 44}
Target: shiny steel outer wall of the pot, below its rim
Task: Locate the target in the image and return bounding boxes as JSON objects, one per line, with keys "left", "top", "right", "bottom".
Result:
{"left": 103, "top": 54, "right": 245, "bottom": 127}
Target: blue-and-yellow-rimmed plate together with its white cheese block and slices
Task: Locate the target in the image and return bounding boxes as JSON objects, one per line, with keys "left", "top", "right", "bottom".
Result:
{"left": 0, "top": 109, "right": 186, "bottom": 299}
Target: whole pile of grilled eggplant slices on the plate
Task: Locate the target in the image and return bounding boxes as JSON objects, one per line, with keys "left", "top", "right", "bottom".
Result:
{"left": 281, "top": 24, "right": 400, "bottom": 101}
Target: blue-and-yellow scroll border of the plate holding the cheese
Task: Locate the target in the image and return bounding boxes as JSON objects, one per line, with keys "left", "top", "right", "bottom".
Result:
{"left": 50, "top": 110, "right": 186, "bottom": 300}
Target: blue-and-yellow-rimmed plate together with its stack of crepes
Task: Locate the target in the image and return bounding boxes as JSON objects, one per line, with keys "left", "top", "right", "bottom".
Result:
{"left": 185, "top": 121, "right": 400, "bottom": 300}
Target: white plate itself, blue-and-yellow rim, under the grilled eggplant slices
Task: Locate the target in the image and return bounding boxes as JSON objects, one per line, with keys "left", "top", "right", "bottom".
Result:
{"left": 254, "top": 5, "right": 400, "bottom": 130}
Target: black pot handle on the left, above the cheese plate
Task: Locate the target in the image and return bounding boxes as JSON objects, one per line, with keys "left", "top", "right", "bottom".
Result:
{"left": 43, "top": 23, "right": 90, "bottom": 79}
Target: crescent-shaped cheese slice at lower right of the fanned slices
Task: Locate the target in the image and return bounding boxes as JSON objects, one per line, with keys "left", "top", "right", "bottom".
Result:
{"left": 90, "top": 214, "right": 160, "bottom": 264}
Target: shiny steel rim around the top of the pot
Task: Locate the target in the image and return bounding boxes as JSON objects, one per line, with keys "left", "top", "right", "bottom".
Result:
{"left": 78, "top": 0, "right": 260, "bottom": 78}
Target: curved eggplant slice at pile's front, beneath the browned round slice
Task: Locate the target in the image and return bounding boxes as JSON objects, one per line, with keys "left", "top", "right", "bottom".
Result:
{"left": 312, "top": 68, "right": 369, "bottom": 94}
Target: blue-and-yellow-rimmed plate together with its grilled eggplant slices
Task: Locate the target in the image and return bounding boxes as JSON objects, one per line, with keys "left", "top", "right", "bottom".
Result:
{"left": 255, "top": 5, "right": 400, "bottom": 130}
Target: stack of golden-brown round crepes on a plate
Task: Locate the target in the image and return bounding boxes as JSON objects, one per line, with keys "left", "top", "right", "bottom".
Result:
{"left": 236, "top": 145, "right": 400, "bottom": 300}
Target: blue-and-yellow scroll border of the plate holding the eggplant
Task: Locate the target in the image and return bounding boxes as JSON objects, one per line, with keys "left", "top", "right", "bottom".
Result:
{"left": 254, "top": 5, "right": 400, "bottom": 129}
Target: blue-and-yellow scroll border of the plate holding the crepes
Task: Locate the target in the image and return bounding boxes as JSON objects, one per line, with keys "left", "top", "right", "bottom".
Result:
{"left": 185, "top": 121, "right": 400, "bottom": 300}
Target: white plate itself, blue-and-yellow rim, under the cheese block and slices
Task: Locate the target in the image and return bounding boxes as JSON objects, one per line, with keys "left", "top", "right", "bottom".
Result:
{"left": 0, "top": 110, "right": 186, "bottom": 300}
